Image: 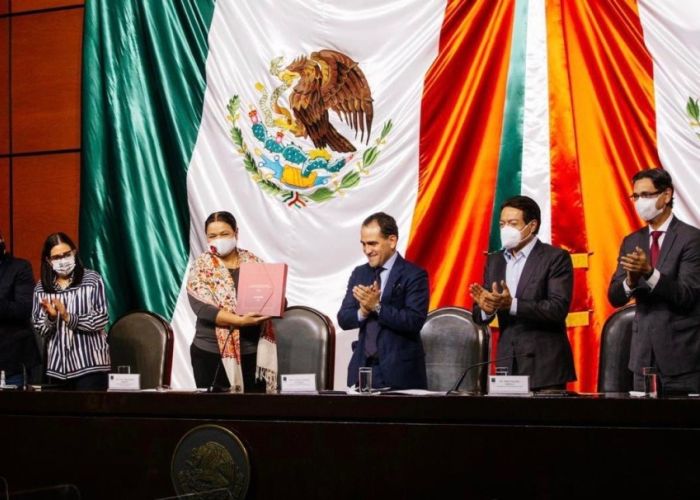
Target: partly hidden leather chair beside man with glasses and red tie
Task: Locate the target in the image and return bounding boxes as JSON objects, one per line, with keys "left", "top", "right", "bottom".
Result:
{"left": 598, "top": 304, "right": 635, "bottom": 392}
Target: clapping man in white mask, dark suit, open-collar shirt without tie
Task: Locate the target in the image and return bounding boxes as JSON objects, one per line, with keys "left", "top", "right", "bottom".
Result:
{"left": 470, "top": 196, "right": 576, "bottom": 390}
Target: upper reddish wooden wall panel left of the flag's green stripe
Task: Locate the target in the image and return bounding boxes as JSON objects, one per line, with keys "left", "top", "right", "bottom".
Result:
{"left": 11, "top": 9, "right": 83, "bottom": 153}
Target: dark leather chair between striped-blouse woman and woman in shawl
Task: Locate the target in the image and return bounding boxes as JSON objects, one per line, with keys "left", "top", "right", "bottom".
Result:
{"left": 108, "top": 311, "right": 173, "bottom": 389}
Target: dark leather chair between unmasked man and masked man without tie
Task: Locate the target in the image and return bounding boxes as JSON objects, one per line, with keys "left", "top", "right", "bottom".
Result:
{"left": 421, "top": 307, "right": 491, "bottom": 393}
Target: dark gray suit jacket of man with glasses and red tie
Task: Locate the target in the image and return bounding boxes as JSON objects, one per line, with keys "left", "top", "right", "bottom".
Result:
{"left": 608, "top": 217, "right": 700, "bottom": 376}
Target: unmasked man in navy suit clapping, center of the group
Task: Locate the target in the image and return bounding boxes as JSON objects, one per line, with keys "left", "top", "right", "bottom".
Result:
{"left": 338, "top": 212, "right": 430, "bottom": 389}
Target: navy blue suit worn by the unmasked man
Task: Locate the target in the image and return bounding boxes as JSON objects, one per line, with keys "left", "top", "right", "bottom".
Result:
{"left": 338, "top": 255, "right": 430, "bottom": 389}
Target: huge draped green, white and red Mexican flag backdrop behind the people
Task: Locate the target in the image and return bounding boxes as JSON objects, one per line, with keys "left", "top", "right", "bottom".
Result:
{"left": 80, "top": 0, "right": 700, "bottom": 391}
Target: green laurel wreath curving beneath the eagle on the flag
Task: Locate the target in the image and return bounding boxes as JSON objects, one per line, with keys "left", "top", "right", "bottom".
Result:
{"left": 226, "top": 95, "right": 394, "bottom": 206}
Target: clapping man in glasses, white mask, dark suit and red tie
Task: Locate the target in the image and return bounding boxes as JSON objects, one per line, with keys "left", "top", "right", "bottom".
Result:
{"left": 608, "top": 169, "right": 700, "bottom": 394}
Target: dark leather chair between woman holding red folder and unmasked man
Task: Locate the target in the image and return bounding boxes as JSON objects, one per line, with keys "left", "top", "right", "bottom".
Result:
{"left": 273, "top": 306, "right": 335, "bottom": 390}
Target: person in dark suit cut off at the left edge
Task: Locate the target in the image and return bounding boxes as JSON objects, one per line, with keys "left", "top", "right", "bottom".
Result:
{"left": 0, "top": 235, "right": 39, "bottom": 385}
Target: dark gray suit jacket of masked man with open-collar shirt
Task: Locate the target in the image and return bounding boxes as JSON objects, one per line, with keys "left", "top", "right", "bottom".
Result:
{"left": 474, "top": 241, "right": 576, "bottom": 389}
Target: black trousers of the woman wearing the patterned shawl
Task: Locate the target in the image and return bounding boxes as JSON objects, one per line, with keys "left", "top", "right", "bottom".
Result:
{"left": 190, "top": 344, "right": 265, "bottom": 393}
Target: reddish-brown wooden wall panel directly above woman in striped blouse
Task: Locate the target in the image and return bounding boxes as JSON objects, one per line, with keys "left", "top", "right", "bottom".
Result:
{"left": 12, "top": 153, "right": 80, "bottom": 276}
